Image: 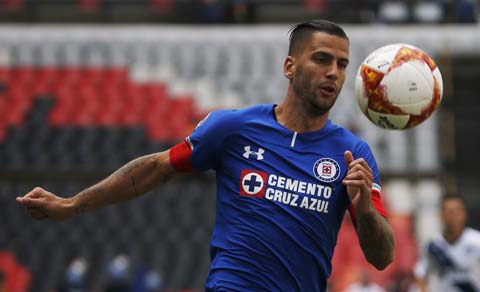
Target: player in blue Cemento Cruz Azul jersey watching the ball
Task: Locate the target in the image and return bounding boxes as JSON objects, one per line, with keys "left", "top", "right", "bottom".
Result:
{"left": 17, "top": 20, "right": 394, "bottom": 291}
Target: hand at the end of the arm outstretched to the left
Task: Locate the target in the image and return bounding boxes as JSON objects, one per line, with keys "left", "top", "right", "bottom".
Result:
{"left": 16, "top": 187, "right": 75, "bottom": 220}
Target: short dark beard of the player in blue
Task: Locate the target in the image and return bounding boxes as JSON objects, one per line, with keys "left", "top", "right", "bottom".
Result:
{"left": 293, "top": 67, "right": 340, "bottom": 116}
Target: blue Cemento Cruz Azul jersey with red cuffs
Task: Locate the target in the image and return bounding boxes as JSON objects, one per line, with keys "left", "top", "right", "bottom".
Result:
{"left": 170, "top": 105, "right": 384, "bottom": 292}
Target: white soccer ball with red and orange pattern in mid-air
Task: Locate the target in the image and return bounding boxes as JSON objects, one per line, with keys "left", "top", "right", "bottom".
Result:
{"left": 355, "top": 44, "right": 443, "bottom": 129}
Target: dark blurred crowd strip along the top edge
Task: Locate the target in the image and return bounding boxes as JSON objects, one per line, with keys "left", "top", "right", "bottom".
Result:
{"left": 0, "top": 0, "right": 478, "bottom": 24}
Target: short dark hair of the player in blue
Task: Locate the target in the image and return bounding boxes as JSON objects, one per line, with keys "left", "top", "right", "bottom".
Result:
{"left": 288, "top": 19, "right": 348, "bottom": 55}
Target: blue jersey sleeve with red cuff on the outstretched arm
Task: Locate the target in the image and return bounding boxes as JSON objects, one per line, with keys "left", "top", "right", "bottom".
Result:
{"left": 170, "top": 110, "right": 235, "bottom": 172}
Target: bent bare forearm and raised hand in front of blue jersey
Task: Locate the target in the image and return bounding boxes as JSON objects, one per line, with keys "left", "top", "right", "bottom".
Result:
{"left": 343, "top": 151, "right": 395, "bottom": 270}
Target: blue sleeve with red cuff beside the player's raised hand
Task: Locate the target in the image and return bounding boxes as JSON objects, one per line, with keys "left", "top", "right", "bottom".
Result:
{"left": 348, "top": 142, "right": 388, "bottom": 220}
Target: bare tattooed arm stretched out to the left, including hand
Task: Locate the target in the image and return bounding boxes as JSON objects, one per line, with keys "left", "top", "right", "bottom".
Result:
{"left": 16, "top": 150, "right": 175, "bottom": 220}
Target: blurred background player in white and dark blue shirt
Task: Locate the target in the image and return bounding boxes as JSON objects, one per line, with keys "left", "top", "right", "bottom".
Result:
{"left": 414, "top": 195, "right": 480, "bottom": 292}
